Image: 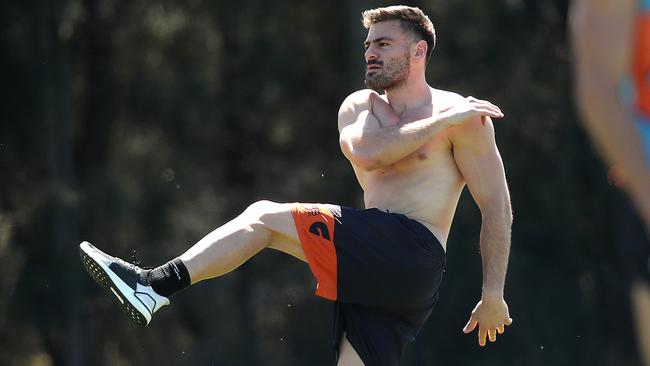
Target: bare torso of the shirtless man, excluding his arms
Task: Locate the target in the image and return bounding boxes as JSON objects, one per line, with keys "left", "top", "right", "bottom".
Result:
{"left": 353, "top": 89, "right": 465, "bottom": 248}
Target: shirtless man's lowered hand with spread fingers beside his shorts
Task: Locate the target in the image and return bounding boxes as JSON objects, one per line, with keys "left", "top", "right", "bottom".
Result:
{"left": 463, "top": 296, "right": 512, "bottom": 347}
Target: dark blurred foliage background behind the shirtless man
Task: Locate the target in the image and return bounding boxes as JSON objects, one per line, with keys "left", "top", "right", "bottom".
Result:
{"left": 0, "top": 0, "right": 638, "bottom": 366}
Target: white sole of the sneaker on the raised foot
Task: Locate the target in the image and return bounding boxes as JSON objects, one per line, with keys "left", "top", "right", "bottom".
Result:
{"left": 79, "top": 242, "right": 149, "bottom": 327}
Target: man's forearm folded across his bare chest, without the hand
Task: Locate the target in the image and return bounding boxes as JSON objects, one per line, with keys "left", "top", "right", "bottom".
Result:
{"left": 350, "top": 117, "right": 449, "bottom": 170}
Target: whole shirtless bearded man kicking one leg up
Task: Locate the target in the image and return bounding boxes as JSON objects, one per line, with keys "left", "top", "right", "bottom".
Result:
{"left": 80, "top": 6, "right": 512, "bottom": 366}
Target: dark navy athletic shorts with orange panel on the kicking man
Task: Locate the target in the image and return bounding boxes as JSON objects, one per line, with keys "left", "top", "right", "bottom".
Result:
{"left": 292, "top": 204, "right": 445, "bottom": 366}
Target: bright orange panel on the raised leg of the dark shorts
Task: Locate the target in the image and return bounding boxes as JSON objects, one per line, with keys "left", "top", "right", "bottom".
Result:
{"left": 291, "top": 203, "right": 337, "bottom": 301}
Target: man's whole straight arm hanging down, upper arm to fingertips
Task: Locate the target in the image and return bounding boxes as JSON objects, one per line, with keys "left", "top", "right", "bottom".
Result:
{"left": 449, "top": 118, "right": 512, "bottom": 346}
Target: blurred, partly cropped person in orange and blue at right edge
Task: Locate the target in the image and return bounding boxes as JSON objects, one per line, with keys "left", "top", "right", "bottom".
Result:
{"left": 570, "top": 0, "right": 650, "bottom": 366}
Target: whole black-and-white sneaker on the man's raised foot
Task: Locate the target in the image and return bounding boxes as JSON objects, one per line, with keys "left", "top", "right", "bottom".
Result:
{"left": 79, "top": 241, "right": 169, "bottom": 326}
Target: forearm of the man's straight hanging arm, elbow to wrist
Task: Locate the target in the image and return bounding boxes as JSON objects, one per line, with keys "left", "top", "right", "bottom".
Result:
{"left": 480, "top": 203, "right": 512, "bottom": 297}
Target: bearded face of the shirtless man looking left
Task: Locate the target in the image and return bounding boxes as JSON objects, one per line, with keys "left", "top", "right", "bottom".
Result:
{"left": 364, "top": 20, "right": 412, "bottom": 90}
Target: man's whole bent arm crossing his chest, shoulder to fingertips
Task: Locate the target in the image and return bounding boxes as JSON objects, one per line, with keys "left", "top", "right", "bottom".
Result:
{"left": 338, "top": 89, "right": 503, "bottom": 171}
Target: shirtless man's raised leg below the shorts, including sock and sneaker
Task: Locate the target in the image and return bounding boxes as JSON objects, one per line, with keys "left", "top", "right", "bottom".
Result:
{"left": 79, "top": 201, "right": 314, "bottom": 326}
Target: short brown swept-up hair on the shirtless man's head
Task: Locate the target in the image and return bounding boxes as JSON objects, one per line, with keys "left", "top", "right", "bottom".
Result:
{"left": 362, "top": 5, "right": 436, "bottom": 61}
